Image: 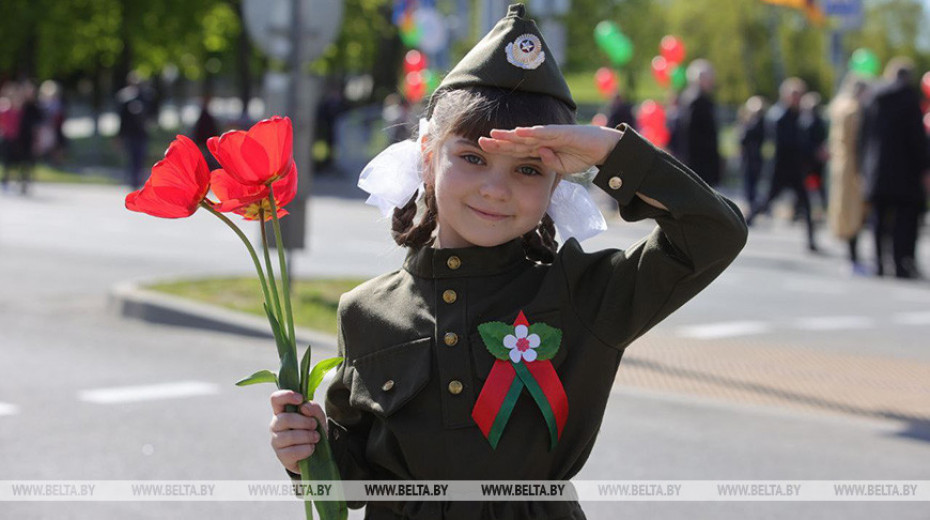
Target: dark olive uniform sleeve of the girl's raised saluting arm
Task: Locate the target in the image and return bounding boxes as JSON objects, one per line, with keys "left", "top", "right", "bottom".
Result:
{"left": 556, "top": 123, "right": 747, "bottom": 349}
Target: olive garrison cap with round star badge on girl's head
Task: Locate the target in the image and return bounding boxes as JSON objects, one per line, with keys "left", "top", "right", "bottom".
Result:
{"left": 429, "top": 4, "right": 577, "bottom": 113}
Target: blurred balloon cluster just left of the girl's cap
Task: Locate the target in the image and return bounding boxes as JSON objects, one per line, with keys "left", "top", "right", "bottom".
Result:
{"left": 392, "top": 0, "right": 449, "bottom": 103}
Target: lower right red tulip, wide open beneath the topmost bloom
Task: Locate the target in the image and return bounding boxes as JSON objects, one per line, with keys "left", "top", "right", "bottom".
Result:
{"left": 210, "top": 163, "right": 297, "bottom": 220}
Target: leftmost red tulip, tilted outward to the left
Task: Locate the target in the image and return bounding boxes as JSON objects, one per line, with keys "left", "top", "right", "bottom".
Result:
{"left": 126, "top": 135, "right": 210, "bottom": 218}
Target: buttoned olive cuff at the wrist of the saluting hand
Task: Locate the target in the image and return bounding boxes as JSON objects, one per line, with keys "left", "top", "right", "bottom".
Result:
{"left": 593, "top": 123, "right": 658, "bottom": 206}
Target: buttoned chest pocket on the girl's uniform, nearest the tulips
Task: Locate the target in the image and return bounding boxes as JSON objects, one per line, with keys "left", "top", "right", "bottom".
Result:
{"left": 349, "top": 338, "right": 432, "bottom": 417}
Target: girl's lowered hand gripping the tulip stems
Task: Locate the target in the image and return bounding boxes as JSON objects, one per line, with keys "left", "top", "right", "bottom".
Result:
{"left": 271, "top": 390, "right": 326, "bottom": 473}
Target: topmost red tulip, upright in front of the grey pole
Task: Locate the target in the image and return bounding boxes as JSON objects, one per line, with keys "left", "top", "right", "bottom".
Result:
{"left": 207, "top": 116, "right": 294, "bottom": 186}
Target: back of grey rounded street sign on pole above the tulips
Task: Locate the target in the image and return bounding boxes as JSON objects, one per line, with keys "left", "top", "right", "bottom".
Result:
{"left": 242, "top": 0, "right": 343, "bottom": 62}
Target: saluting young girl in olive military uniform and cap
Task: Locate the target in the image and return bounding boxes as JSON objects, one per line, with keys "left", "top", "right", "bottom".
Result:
{"left": 271, "top": 5, "right": 746, "bottom": 519}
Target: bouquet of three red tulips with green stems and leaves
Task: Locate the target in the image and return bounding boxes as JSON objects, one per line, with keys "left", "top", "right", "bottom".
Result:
{"left": 126, "top": 116, "right": 348, "bottom": 520}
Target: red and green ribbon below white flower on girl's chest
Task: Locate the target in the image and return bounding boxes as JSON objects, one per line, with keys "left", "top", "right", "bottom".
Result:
{"left": 471, "top": 312, "right": 568, "bottom": 450}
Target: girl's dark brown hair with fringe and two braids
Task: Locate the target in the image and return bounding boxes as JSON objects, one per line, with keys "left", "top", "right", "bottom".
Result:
{"left": 391, "top": 87, "right": 575, "bottom": 263}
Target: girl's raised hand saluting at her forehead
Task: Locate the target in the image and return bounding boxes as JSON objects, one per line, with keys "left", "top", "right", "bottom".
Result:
{"left": 478, "top": 125, "right": 623, "bottom": 174}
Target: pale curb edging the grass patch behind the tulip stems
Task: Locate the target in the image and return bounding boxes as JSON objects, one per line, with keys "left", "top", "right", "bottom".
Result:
{"left": 108, "top": 280, "right": 337, "bottom": 351}
